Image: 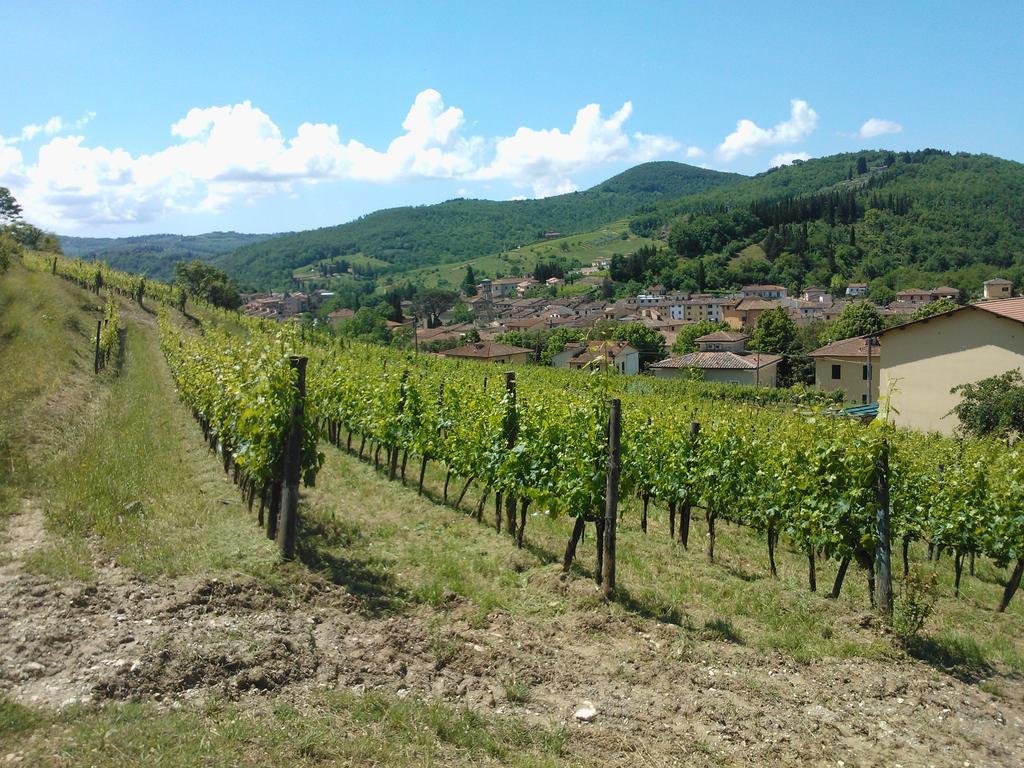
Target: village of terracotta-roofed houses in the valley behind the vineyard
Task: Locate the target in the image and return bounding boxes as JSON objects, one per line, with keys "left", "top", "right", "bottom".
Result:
{"left": 243, "top": 261, "right": 1024, "bottom": 433}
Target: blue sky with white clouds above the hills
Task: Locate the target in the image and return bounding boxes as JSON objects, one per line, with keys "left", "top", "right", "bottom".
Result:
{"left": 0, "top": 0, "right": 1024, "bottom": 237}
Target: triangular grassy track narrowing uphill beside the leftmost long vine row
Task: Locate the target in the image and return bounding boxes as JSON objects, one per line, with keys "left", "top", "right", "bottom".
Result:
{"left": 37, "top": 313, "right": 275, "bottom": 577}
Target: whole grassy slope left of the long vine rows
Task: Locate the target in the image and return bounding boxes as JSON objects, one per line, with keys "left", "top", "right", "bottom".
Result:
{"left": 0, "top": 256, "right": 273, "bottom": 575}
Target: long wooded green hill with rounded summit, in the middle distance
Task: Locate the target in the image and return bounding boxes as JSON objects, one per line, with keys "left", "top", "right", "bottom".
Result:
{"left": 216, "top": 162, "right": 744, "bottom": 285}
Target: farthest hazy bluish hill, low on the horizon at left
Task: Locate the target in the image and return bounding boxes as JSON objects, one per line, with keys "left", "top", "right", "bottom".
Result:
{"left": 60, "top": 232, "right": 278, "bottom": 280}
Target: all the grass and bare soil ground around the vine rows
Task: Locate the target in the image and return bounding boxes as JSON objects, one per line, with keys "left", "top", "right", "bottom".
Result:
{"left": 0, "top": 260, "right": 1024, "bottom": 768}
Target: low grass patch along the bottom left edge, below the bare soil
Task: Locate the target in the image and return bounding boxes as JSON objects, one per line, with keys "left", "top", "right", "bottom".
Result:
{"left": 0, "top": 691, "right": 579, "bottom": 768}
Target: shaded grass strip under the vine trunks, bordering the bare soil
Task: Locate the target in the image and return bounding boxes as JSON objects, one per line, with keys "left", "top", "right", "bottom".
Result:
{"left": 303, "top": 447, "right": 1024, "bottom": 673}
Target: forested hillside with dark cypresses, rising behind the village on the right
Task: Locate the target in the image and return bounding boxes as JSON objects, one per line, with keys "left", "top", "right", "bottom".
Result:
{"left": 612, "top": 150, "right": 1024, "bottom": 301}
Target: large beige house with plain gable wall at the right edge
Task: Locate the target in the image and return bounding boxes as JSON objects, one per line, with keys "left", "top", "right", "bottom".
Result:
{"left": 879, "top": 298, "right": 1024, "bottom": 434}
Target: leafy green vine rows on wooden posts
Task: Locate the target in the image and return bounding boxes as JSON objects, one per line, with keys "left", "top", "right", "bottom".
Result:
{"left": 27, "top": 249, "right": 1024, "bottom": 611}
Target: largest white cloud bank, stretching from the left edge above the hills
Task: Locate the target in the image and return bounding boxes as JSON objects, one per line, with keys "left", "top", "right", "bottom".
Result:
{"left": 0, "top": 89, "right": 679, "bottom": 230}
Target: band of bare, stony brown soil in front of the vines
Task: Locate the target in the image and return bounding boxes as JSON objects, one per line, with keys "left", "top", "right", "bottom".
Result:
{"left": 0, "top": 504, "right": 1024, "bottom": 767}
